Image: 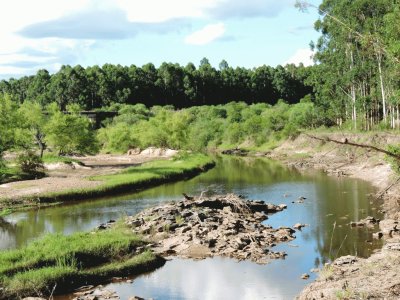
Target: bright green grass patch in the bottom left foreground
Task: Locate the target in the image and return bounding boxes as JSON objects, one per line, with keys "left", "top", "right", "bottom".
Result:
{"left": 0, "top": 224, "right": 164, "bottom": 299}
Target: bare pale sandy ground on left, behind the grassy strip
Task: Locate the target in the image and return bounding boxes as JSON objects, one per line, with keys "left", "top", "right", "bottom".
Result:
{"left": 0, "top": 154, "right": 170, "bottom": 201}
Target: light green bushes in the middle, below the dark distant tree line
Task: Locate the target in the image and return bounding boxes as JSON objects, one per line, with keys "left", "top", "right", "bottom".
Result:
{"left": 98, "top": 101, "right": 318, "bottom": 152}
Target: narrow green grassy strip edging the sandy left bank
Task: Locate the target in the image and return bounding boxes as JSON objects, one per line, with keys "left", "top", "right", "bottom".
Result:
{"left": 0, "top": 154, "right": 215, "bottom": 211}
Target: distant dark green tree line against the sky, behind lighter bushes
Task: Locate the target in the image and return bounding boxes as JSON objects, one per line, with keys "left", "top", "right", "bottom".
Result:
{"left": 0, "top": 58, "right": 311, "bottom": 110}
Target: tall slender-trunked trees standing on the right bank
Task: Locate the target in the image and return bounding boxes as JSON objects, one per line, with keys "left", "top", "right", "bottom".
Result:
{"left": 297, "top": 0, "right": 400, "bottom": 130}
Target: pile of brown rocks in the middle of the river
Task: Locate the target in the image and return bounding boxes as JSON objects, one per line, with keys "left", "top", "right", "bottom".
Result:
{"left": 127, "top": 194, "right": 295, "bottom": 263}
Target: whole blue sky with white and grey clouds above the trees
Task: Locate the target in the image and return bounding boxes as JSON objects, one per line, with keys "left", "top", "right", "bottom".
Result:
{"left": 0, "top": 0, "right": 321, "bottom": 79}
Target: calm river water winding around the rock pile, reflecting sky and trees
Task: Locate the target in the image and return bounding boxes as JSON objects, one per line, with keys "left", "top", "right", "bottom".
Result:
{"left": 0, "top": 157, "right": 382, "bottom": 299}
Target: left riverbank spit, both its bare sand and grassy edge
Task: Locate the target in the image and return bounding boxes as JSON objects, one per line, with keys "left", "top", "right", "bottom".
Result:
{"left": 0, "top": 154, "right": 215, "bottom": 211}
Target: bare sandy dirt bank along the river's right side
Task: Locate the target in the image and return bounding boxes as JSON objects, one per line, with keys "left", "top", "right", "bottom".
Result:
{"left": 268, "top": 133, "right": 400, "bottom": 299}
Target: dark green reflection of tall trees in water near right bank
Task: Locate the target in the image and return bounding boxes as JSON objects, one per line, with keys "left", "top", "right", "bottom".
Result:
{"left": 312, "top": 177, "right": 380, "bottom": 263}
